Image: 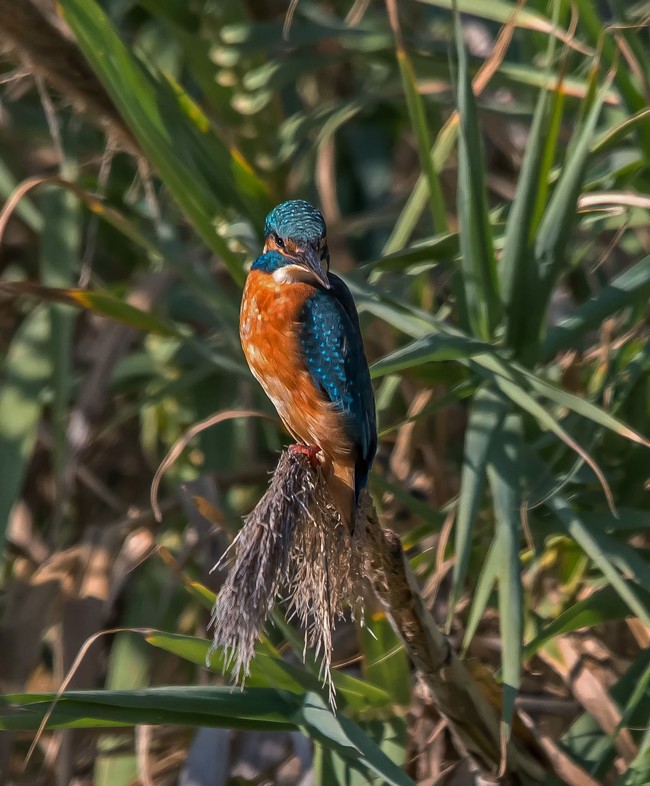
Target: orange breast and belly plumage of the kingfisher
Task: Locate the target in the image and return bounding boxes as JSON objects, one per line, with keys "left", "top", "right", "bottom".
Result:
{"left": 239, "top": 270, "right": 351, "bottom": 458}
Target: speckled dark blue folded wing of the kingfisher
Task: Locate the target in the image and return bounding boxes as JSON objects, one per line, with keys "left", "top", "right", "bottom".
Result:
{"left": 300, "top": 274, "right": 377, "bottom": 499}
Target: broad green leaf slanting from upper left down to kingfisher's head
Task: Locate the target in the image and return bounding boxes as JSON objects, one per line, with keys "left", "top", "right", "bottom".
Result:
{"left": 61, "top": 0, "right": 269, "bottom": 282}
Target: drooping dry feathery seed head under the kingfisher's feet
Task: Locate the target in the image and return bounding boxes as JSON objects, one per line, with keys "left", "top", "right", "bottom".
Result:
{"left": 211, "top": 452, "right": 363, "bottom": 706}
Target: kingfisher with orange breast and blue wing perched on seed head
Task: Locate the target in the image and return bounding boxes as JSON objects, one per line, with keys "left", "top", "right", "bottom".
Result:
{"left": 239, "top": 199, "right": 377, "bottom": 534}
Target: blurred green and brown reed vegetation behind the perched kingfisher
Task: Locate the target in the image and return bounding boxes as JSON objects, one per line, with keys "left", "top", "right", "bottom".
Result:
{"left": 0, "top": 0, "right": 650, "bottom": 786}
